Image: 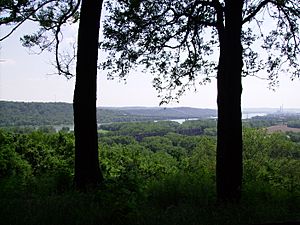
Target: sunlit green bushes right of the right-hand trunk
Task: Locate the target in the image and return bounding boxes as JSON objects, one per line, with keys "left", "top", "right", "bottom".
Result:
{"left": 244, "top": 129, "right": 300, "bottom": 191}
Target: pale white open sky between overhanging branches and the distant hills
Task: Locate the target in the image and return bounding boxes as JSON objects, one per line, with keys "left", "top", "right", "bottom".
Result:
{"left": 0, "top": 21, "right": 300, "bottom": 109}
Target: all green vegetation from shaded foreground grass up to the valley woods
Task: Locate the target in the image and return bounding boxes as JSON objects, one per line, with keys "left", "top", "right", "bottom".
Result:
{"left": 0, "top": 121, "right": 300, "bottom": 225}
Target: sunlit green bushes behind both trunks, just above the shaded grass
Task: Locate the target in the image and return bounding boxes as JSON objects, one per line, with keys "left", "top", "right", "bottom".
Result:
{"left": 0, "top": 123, "right": 300, "bottom": 193}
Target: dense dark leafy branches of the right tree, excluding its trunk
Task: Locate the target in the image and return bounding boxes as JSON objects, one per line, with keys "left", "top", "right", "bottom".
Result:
{"left": 101, "top": 0, "right": 300, "bottom": 103}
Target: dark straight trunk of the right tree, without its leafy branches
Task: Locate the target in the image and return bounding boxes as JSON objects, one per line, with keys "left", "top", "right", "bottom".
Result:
{"left": 216, "top": 0, "right": 243, "bottom": 201}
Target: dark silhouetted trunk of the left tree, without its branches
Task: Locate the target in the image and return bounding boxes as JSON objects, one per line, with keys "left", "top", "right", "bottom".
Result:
{"left": 73, "top": 0, "right": 103, "bottom": 190}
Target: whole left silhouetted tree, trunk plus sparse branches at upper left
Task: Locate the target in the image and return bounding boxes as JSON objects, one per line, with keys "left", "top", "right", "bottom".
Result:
{"left": 0, "top": 0, "right": 103, "bottom": 190}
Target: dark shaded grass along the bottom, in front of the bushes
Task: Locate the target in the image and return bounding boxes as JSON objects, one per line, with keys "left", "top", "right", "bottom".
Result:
{"left": 0, "top": 174, "right": 300, "bottom": 225}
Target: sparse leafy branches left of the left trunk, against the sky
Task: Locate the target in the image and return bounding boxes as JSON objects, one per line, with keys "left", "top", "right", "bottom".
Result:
{"left": 0, "top": 0, "right": 81, "bottom": 78}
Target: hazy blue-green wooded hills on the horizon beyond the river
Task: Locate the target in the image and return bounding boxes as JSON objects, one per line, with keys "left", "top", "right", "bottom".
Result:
{"left": 0, "top": 101, "right": 216, "bottom": 127}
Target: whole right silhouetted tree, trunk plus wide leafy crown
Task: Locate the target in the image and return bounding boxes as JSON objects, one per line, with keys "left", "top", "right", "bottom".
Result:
{"left": 101, "top": 0, "right": 300, "bottom": 201}
